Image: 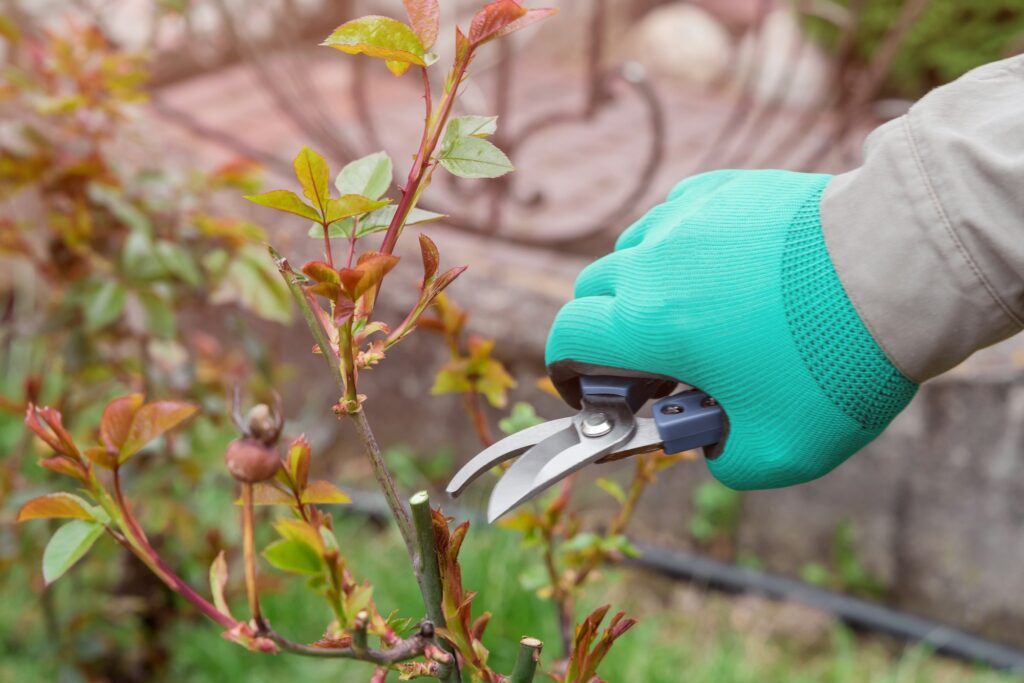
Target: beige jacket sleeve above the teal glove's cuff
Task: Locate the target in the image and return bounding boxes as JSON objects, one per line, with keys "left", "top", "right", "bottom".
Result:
{"left": 821, "top": 55, "right": 1024, "bottom": 382}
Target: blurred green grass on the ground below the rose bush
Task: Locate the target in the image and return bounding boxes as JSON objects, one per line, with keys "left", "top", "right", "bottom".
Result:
{"left": 0, "top": 511, "right": 1019, "bottom": 683}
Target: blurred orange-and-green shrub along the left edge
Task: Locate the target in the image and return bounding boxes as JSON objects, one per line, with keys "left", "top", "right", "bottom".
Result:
{"left": 0, "top": 18, "right": 292, "bottom": 678}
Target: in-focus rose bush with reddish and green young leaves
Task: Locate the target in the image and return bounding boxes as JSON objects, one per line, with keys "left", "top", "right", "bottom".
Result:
{"left": 8, "top": 0, "right": 678, "bottom": 683}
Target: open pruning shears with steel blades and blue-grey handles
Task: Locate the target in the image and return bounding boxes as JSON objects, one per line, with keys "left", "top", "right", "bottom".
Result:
{"left": 447, "top": 375, "right": 725, "bottom": 522}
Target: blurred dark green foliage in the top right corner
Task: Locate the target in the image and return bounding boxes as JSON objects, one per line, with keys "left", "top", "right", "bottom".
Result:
{"left": 814, "top": 0, "right": 1024, "bottom": 98}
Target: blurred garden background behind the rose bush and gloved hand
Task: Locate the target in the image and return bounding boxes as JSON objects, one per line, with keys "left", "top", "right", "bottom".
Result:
{"left": 0, "top": 0, "right": 1024, "bottom": 683}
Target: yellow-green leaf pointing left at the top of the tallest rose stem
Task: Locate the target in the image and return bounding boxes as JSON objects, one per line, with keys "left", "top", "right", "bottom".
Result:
{"left": 321, "top": 15, "right": 425, "bottom": 76}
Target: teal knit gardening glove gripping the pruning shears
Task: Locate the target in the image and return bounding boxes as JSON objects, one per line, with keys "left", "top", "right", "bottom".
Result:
{"left": 547, "top": 171, "right": 918, "bottom": 489}
